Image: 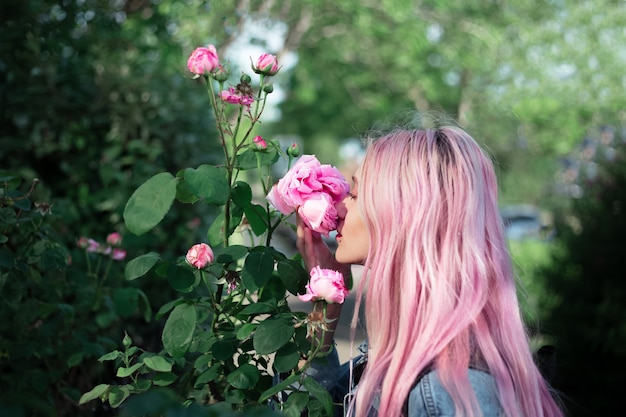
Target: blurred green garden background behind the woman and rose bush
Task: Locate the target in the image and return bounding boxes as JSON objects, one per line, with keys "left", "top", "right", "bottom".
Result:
{"left": 0, "top": 0, "right": 626, "bottom": 416}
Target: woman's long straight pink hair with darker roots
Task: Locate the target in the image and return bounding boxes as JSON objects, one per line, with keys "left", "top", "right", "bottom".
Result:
{"left": 353, "top": 127, "right": 562, "bottom": 417}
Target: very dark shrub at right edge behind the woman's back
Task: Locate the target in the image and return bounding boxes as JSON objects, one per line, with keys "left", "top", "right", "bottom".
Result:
{"left": 542, "top": 141, "right": 626, "bottom": 416}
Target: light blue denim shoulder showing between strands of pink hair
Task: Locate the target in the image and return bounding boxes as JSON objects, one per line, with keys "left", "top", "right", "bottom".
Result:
{"left": 408, "top": 369, "right": 503, "bottom": 417}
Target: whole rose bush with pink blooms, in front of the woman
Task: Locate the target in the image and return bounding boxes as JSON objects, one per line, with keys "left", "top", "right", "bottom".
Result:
{"left": 80, "top": 45, "right": 348, "bottom": 416}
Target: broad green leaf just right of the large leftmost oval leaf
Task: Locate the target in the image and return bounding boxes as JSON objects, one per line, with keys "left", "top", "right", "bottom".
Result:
{"left": 184, "top": 165, "right": 229, "bottom": 205}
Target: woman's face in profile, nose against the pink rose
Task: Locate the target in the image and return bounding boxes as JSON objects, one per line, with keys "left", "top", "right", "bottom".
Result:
{"left": 335, "top": 167, "right": 370, "bottom": 264}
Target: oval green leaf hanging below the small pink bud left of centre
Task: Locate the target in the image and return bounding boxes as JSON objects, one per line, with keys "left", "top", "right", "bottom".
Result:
{"left": 162, "top": 304, "right": 198, "bottom": 358}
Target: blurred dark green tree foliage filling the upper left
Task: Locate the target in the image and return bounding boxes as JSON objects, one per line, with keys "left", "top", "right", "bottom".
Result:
{"left": 0, "top": 0, "right": 218, "bottom": 251}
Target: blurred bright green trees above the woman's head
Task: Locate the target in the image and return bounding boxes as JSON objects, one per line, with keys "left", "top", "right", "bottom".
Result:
{"left": 184, "top": 0, "right": 626, "bottom": 204}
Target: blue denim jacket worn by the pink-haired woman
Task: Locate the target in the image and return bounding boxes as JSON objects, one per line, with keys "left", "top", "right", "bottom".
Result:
{"left": 308, "top": 342, "right": 504, "bottom": 417}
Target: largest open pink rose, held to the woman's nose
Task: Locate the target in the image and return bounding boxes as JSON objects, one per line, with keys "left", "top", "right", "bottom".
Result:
{"left": 267, "top": 155, "right": 350, "bottom": 236}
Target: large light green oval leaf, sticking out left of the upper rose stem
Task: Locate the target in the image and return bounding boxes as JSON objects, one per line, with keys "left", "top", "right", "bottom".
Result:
{"left": 124, "top": 172, "right": 176, "bottom": 236}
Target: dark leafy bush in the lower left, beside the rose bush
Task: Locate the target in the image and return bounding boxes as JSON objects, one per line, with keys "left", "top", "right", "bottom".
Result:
{"left": 0, "top": 171, "right": 152, "bottom": 415}
